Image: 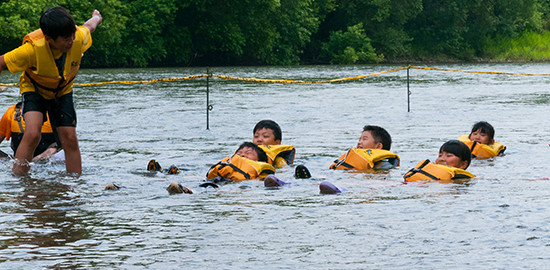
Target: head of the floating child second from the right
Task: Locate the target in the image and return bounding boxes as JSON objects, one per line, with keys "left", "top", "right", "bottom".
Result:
{"left": 435, "top": 140, "right": 472, "bottom": 170}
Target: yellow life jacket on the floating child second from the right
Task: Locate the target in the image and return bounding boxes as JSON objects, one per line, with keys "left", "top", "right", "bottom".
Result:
{"left": 403, "top": 159, "right": 475, "bottom": 183}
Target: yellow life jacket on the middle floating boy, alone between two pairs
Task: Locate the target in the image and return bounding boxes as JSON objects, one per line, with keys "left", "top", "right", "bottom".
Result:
{"left": 330, "top": 148, "right": 400, "bottom": 170}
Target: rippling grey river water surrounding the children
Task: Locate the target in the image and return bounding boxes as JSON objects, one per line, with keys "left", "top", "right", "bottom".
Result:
{"left": 0, "top": 63, "right": 550, "bottom": 269}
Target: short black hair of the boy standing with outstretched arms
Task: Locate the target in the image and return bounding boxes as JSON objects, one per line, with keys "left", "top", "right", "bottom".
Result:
{"left": 40, "top": 7, "right": 76, "bottom": 40}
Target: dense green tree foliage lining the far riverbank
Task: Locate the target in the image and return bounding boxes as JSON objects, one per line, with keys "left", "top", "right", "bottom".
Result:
{"left": 0, "top": 0, "right": 550, "bottom": 67}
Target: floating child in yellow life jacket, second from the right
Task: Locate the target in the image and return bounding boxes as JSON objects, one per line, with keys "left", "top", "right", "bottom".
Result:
{"left": 403, "top": 140, "right": 475, "bottom": 183}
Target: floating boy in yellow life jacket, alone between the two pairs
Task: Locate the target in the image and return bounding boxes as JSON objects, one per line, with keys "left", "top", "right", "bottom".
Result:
{"left": 330, "top": 125, "right": 399, "bottom": 171}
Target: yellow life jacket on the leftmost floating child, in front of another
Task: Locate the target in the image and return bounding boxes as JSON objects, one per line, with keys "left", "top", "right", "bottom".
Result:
{"left": 206, "top": 155, "right": 275, "bottom": 181}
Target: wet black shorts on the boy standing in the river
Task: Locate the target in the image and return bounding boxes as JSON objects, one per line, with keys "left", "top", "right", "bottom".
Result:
{"left": 23, "top": 92, "right": 76, "bottom": 128}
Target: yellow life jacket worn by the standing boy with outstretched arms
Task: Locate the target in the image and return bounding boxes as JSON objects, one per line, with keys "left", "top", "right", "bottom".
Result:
{"left": 20, "top": 29, "right": 82, "bottom": 99}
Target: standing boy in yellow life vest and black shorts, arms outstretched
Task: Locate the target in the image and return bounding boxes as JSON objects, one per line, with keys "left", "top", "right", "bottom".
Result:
{"left": 0, "top": 7, "right": 102, "bottom": 175}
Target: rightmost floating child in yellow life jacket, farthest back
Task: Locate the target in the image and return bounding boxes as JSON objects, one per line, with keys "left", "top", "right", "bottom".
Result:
{"left": 458, "top": 121, "right": 506, "bottom": 158}
